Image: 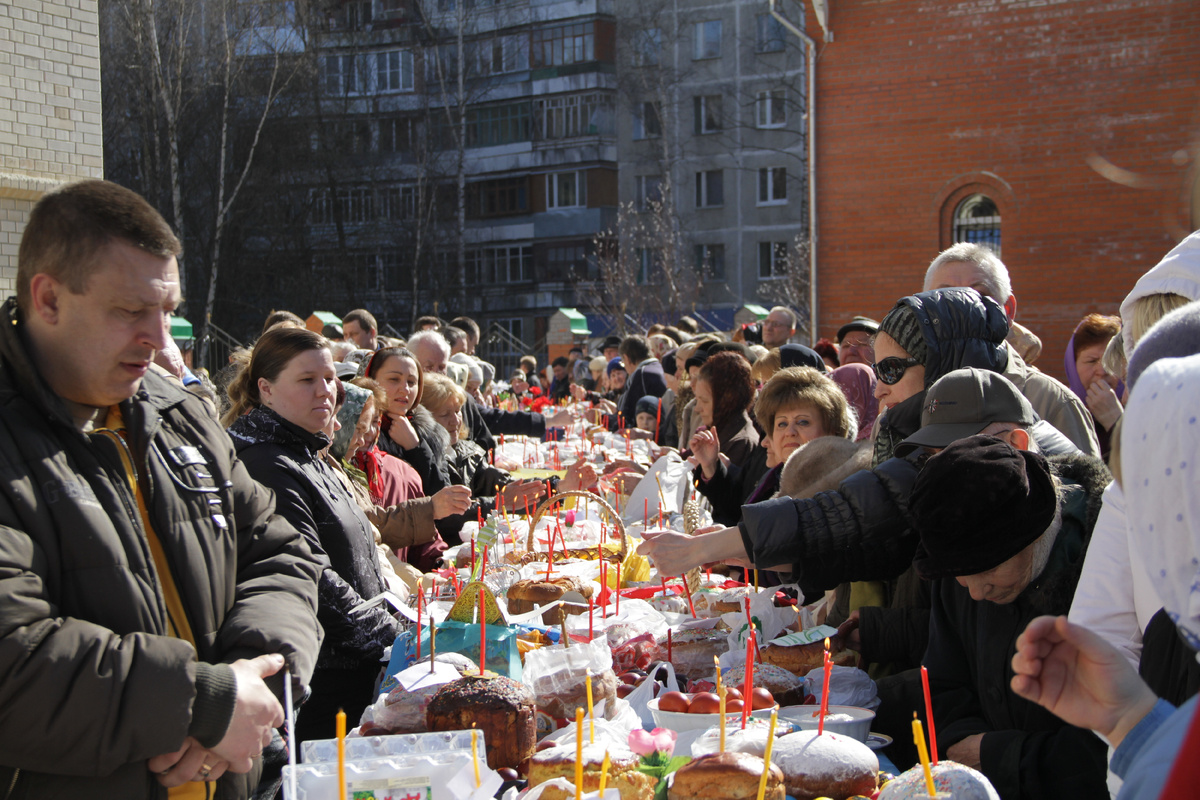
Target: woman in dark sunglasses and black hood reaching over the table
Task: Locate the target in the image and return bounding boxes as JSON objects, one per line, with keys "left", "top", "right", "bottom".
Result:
{"left": 638, "top": 289, "right": 1008, "bottom": 602}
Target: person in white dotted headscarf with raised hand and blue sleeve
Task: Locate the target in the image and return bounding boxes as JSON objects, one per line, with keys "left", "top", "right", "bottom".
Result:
{"left": 1013, "top": 355, "right": 1200, "bottom": 799}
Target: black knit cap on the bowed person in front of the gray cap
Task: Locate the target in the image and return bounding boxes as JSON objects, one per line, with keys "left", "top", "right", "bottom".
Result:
{"left": 908, "top": 435, "right": 1058, "bottom": 579}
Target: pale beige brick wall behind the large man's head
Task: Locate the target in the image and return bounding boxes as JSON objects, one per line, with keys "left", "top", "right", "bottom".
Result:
{"left": 0, "top": 0, "right": 104, "bottom": 296}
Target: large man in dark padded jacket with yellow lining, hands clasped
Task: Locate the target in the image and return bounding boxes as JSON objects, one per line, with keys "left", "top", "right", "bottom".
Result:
{"left": 0, "top": 181, "right": 320, "bottom": 800}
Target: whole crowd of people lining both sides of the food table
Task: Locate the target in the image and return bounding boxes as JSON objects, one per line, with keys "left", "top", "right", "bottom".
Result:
{"left": 0, "top": 181, "right": 1200, "bottom": 798}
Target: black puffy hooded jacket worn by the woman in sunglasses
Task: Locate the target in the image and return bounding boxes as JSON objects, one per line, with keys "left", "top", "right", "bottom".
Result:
{"left": 742, "top": 289, "right": 1008, "bottom": 589}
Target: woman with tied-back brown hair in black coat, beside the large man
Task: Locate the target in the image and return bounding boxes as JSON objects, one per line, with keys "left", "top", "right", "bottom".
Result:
{"left": 224, "top": 327, "right": 400, "bottom": 741}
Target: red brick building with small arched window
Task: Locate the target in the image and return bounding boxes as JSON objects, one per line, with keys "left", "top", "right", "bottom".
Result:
{"left": 804, "top": 0, "right": 1200, "bottom": 377}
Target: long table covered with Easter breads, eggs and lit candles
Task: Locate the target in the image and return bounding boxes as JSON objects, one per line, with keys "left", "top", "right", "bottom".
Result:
{"left": 284, "top": 426, "right": 998, "bottom": 800}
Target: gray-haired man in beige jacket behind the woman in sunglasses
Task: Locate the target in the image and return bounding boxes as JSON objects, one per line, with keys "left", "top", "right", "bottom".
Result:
{"left": 924, "top": 242, "right": 1100, "bottom": 456}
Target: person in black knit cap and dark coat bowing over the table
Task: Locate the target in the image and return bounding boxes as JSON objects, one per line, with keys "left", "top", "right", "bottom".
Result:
{"left": 910, "top": 435, "right": 1108, "bottom": 800}
